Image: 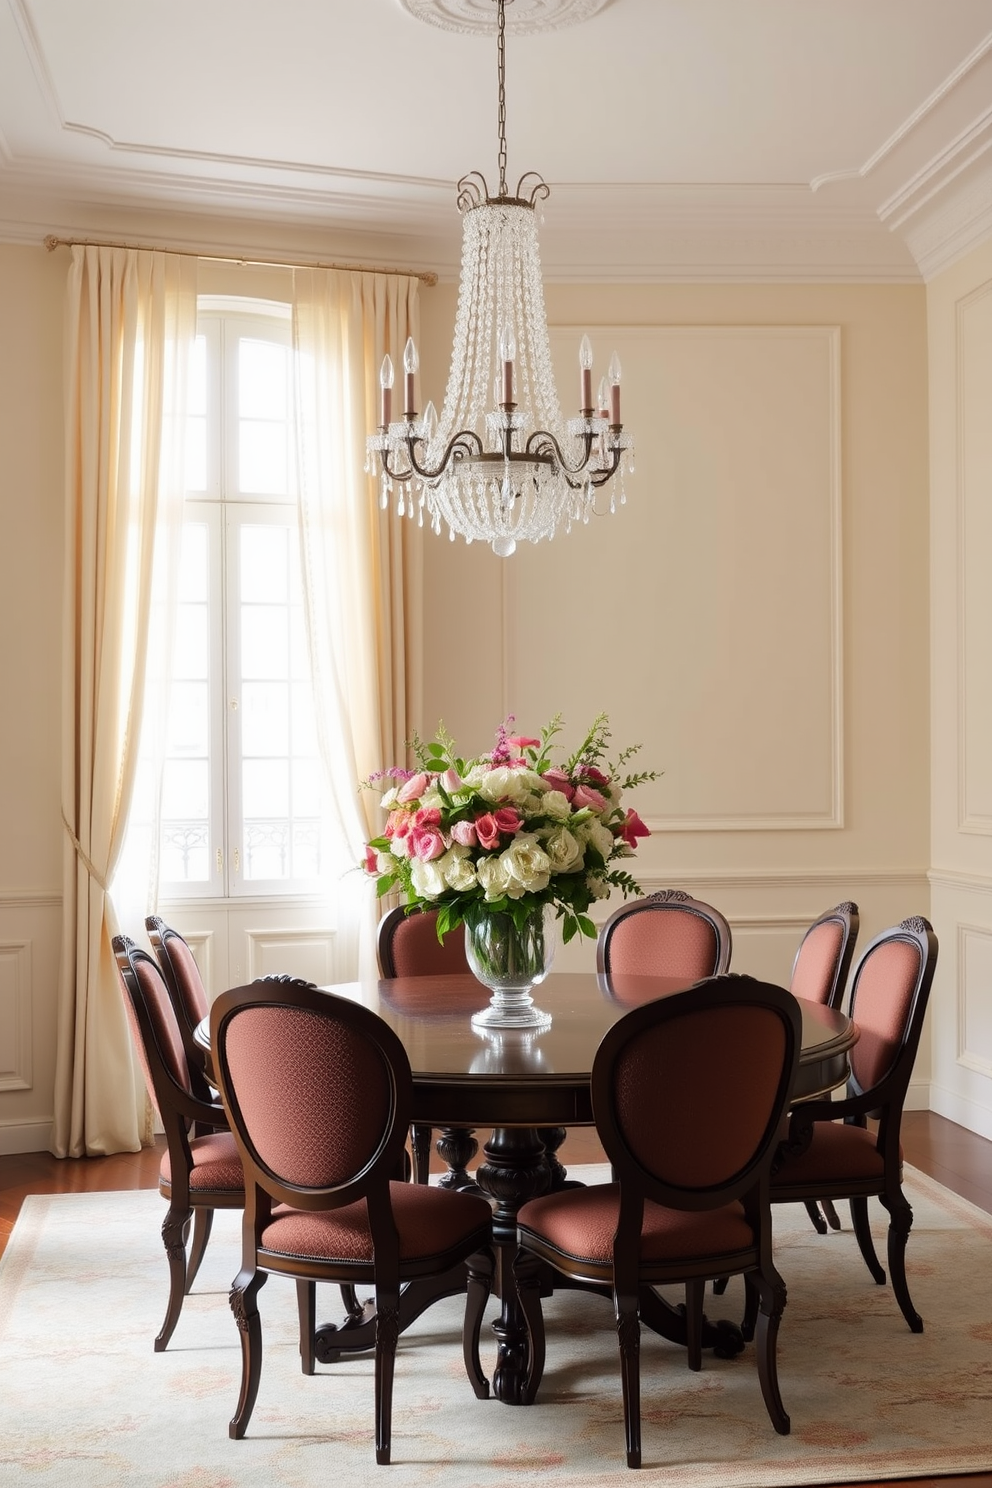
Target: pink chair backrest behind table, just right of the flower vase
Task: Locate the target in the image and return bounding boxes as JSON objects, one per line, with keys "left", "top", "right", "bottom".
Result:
{"left": 596, "top": 888, "right": 733, "bottom": 981}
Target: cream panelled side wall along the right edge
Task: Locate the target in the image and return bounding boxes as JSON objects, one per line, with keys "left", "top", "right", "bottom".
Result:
{"left": 927, "top": 243, "right": 992, "bottom": 1137}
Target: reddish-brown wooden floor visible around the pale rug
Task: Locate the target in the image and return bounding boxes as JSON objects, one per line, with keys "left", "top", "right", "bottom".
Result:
{"left": 0, "top": 1112, "right": 992, "bottom": 1488}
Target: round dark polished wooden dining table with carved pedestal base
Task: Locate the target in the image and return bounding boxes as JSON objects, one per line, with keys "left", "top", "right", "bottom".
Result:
{"left": 198, "top": 972, "right": 857, "bottom": 1403}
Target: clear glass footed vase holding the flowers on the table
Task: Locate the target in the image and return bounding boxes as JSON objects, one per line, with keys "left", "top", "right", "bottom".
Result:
{"left": 466, "top": 905, "right": 555, "bottom": 1028}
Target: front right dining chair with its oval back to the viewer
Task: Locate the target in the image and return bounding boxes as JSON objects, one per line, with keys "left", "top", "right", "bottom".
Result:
{"left": 515, "top": 976, "right": 802, "bottom": 1467}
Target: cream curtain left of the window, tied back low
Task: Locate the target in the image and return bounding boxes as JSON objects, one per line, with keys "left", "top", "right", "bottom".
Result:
{"left": 52, "top": 247, "right": 196, "bottom": 1158}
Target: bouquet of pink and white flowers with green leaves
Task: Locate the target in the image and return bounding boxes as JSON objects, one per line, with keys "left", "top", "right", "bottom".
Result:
{"left": 364, "top": 713, "right": 657, "bottom": 942}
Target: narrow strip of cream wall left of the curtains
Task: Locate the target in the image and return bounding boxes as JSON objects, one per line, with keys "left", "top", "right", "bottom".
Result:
{"left": 0, "top": 247, "right": 68, "bottom": 1152}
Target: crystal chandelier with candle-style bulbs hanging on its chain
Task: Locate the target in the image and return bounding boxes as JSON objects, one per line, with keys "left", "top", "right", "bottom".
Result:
{"left": 366, "top": 0, "right": 634, "bottom": 558}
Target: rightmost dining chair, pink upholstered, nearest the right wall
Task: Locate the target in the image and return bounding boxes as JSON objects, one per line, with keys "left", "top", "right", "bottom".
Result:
{"left": 772, "top": 917, "right": 937, "bottom": 1333}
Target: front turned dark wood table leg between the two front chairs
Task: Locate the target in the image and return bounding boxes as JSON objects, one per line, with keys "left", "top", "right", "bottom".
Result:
{"left": 476, "top": 1126, "right": 552, "bottom": 1405}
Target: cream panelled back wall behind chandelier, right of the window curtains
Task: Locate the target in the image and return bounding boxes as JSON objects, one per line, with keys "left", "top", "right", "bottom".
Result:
{"left": 422, "top": 286, "right": 930, "bottom": 1104}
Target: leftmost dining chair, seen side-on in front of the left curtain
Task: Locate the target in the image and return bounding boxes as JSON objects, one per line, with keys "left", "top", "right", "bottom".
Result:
{"left": 113, "top": 934, "right": 244, "bottom": 1353}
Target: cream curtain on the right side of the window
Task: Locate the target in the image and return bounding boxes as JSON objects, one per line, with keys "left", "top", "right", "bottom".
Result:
{"left": 293, "top": 269, "right": 422, "bottom": 976}
